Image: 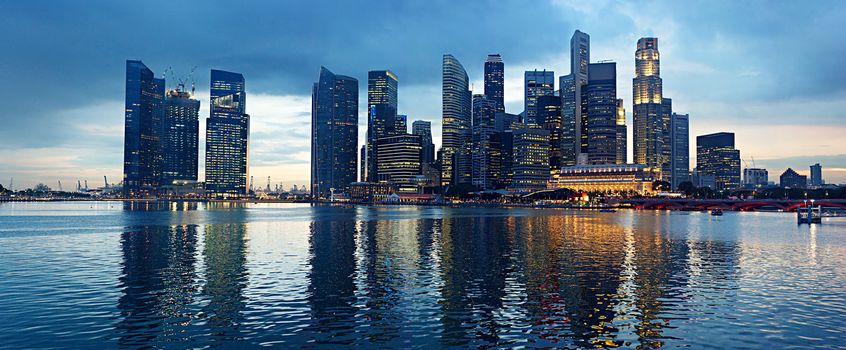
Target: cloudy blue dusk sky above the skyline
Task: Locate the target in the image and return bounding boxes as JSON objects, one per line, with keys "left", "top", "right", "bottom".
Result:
{"left": 0, "top": 0, "right": 846, "bottom": 190}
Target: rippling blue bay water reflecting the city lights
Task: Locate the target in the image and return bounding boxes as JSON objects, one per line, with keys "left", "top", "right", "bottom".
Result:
{"left": 0, "top": 202, "right": 846, "bottom": 349}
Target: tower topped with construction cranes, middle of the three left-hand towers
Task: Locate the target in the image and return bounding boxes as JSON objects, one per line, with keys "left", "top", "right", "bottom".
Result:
{"left": 161, "top": 84, "right": 200, "bottom": 185}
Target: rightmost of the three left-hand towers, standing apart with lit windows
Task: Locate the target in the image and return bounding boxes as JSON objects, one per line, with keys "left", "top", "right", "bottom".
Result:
{"left": 206, "top": 69, "right": 250, "bottom": 197}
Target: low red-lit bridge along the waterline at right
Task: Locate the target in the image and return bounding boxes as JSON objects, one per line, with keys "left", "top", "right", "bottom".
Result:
{"left": 608, "top": 198, "right": 846, "bottom": 211}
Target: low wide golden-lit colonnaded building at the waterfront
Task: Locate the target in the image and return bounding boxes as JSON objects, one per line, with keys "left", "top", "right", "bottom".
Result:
{"left": 549, "top": 164, "right": 660, "bottom": 195}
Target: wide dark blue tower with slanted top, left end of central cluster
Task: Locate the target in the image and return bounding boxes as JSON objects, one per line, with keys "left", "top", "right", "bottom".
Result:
{"left": 311, "top": 67, "right": 358, "bottom": 198}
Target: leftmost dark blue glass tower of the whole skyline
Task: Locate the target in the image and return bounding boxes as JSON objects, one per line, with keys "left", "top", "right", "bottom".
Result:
{"left": 123, "top": 60, "right": 165, "bottom": 197}
